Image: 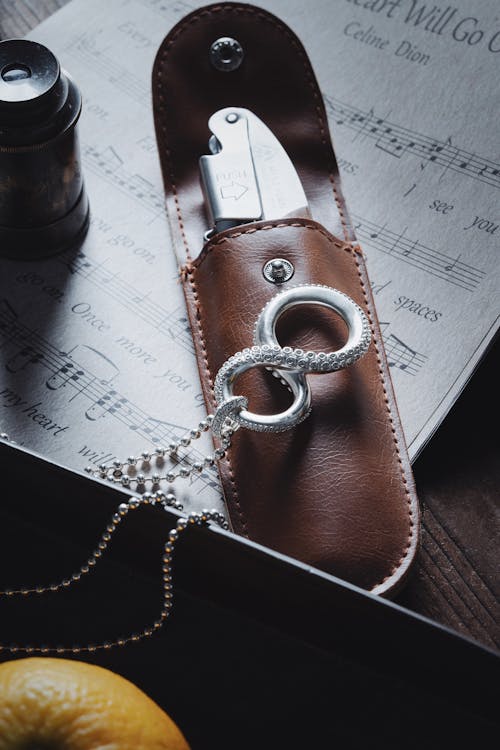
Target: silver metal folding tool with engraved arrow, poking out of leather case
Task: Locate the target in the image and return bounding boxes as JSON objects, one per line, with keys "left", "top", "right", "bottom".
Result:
{"left": 200, "top": 107, "right": 310, "bottom": 238}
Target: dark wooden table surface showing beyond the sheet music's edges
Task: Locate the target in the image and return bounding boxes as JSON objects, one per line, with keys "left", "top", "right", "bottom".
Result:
{"left": 0, "top": 0, "right": 500, "bottom": 649}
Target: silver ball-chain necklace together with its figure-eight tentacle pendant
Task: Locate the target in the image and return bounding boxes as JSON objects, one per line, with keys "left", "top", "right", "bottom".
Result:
{"left": 0, "top": 285, "right": 371, "bottom": 654}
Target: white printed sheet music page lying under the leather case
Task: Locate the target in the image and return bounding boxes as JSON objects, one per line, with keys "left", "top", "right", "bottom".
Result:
{"left": 0, "top": 0, "right": 500, "bottom": 509}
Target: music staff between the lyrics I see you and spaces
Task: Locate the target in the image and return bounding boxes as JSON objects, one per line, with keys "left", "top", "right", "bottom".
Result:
{"left": 352, "top": 214, "right": 486, "bottom": 292}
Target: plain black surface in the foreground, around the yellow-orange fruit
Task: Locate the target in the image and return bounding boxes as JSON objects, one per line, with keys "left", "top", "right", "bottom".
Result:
{"left": 0, "top": 443, "right": 500, "bottom": 750}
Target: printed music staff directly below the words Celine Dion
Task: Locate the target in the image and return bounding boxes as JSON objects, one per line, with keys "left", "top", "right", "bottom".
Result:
{"left": 324, "top": 94, "right": 500, "bottom": 194}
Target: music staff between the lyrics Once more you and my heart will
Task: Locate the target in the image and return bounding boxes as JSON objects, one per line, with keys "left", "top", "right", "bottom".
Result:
{"left": 0, "top": 300, "right": 218, "bottom": 496}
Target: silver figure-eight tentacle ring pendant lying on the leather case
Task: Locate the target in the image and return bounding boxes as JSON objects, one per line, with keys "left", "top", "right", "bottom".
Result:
{"left": 215, "top": 284, "right": 371, "bottom": 432}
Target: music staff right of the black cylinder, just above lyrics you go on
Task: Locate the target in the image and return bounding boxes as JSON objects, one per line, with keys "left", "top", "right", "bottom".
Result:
{"left": 82, "top": 143, "right": 165, "bottom": 218}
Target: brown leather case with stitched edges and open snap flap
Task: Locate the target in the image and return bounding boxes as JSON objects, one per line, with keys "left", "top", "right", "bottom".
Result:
{"left": 153, "top": 3, "right": 419, "bottom": 595}
